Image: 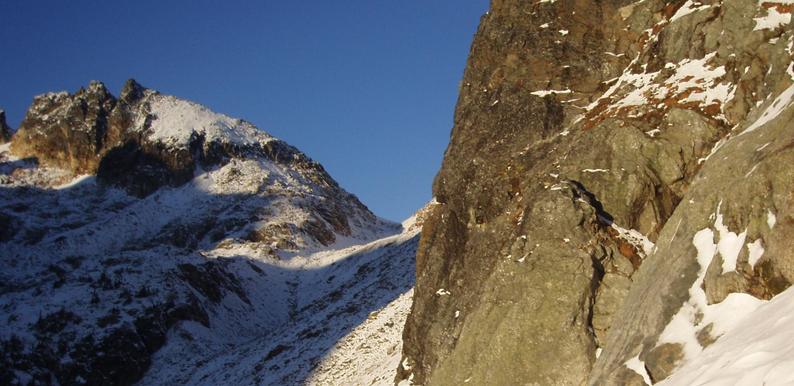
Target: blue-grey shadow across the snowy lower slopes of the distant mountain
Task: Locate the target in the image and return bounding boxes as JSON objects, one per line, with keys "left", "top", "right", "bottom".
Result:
{"left": 0, "top": 164, "right": 418, "bottom": 384}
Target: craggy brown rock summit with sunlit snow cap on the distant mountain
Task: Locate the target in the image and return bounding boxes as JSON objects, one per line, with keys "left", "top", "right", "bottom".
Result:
{"left": 11, "top": 79, "right": 296, "bottom": 196}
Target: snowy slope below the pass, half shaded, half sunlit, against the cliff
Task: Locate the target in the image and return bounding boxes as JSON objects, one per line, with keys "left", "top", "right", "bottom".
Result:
{"left": 141, "top": 229, "right": 419, "bottom": 385}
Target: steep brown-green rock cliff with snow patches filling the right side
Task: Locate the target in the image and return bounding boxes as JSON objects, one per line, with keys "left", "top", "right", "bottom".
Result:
{"left": 398, "top": 0, "right": 794, "bottom": 385}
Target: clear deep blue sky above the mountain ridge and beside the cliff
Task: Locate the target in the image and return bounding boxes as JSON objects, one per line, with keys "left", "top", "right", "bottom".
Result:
{"left": 0, "top": 0, "right": 488, "bottom": 220}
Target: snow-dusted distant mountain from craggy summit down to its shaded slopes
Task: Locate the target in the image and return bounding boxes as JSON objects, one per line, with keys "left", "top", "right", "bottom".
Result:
{"left": 0, "top": 82, "right": 418, "bottom": 384}
